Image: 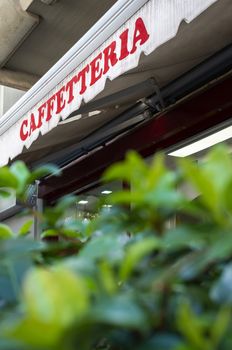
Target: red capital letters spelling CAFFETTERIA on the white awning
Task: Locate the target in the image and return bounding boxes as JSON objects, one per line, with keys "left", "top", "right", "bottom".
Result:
{"left": 20, "top": 17, "right": 149, "bottom": 141}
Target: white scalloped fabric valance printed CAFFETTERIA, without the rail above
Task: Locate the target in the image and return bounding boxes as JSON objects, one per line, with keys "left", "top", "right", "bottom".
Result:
{"left": 0, "top": 0, "right": 218, "bottom": 165}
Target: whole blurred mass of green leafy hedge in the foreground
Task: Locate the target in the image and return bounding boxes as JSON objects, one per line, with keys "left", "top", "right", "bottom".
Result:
{"left": 0, "top": 146, "right": 232, "bottom": 350}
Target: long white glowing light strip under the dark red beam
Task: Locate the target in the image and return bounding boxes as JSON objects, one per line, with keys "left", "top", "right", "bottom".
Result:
{"left": 168, "top": 126, "right": 232, "bottom": 157}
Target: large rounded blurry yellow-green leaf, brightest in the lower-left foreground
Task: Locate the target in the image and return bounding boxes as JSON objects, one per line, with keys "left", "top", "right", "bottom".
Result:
{"left": 23, "top": 267, "right": 89, "bottom": 327}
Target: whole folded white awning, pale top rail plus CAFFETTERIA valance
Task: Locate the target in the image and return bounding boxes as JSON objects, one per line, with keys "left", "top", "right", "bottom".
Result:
{"left": 0, "top": 0, "right": 220, "bottom": 165}
